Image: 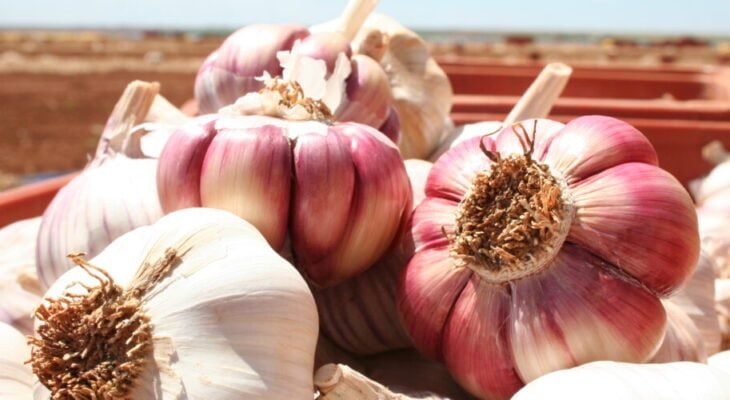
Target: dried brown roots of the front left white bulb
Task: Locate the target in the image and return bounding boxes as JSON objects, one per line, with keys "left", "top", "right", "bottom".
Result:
{"left": 29, "top": 250, "right": 177, "bottom": 400}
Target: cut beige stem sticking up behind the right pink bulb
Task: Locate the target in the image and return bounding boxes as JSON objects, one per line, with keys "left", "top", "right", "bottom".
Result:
{"left": 504, "top": 63, "right": 573, "bottom": 125}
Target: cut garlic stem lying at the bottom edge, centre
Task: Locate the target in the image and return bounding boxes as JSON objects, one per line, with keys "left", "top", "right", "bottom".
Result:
{"left": 314, "top": 364, "right": 432, "bottom": 400}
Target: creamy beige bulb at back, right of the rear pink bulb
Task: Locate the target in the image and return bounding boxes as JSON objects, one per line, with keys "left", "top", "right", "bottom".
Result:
{"left": 346, "top": 14, "right": 453, "bottom": 159}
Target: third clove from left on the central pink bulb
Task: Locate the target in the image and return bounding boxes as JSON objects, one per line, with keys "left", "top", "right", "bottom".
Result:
{"left": 291, "top": 129, "right": 356, "bottom": 264}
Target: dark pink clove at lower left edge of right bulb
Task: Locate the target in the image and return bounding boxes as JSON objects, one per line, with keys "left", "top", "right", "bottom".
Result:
{"left": 398, "top": 247, "right": 472, "bottom": 360}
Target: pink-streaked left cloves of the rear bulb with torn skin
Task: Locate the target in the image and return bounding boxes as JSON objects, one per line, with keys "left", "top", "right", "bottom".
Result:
{"left": 195, "top": 24, "right": 309, "bottom": 114}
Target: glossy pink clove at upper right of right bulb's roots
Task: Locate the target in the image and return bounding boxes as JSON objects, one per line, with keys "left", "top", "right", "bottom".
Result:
{"left": 538, "top": 115, "right": 658, "bottom": 182}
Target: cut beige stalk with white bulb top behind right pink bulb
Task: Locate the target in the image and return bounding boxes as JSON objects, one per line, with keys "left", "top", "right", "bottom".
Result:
{"left": 429, "top": 63, "right": 573, "bottom": 161}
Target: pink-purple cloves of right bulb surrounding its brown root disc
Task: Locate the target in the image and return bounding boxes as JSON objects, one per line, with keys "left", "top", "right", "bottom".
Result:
{"left": 399, "top": 116, "right": 699, "bottom": 399}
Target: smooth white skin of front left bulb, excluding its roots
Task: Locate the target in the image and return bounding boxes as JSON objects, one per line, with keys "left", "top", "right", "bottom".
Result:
{"left": 35, "top": 209, "right": 318, "bottom": 400}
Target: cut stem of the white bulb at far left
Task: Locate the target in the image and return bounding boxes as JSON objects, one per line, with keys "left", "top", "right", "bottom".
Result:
{"left": 96, "top": 81, "right": 160, "bottom": 157}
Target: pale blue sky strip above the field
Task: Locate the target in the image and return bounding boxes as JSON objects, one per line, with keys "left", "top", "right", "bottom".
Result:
{"left": 0, "top": 0, "right": 730, "bottom": 36}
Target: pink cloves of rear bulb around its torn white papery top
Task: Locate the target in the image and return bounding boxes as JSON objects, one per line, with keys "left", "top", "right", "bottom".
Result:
{"left": 195, "top": 25, "right": 393, "bottom": 128}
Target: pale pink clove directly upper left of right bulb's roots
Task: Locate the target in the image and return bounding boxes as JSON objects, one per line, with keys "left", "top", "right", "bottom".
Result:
{"left": 426, "top": 132, "right": 496, "bottom": 202}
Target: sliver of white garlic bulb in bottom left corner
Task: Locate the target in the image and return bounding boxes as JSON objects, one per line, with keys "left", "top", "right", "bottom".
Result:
{"left": 0, "top": 322, "right": 33, "bottom": 400}
